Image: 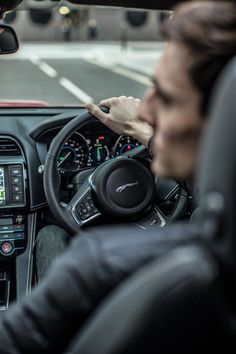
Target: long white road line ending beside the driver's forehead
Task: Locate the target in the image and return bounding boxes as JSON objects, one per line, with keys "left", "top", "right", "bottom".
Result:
{"left": 85, "top": 58, "right": 152, "bottom": 86}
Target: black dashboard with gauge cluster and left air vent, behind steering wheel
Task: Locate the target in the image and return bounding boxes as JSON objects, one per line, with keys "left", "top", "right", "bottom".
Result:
{"left": 0, "top": 107, "right": 176, "bottom": 213}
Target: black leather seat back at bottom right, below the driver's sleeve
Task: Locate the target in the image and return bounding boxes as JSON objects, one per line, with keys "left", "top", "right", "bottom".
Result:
{"left": 66, "top": 246, "right": 228, "bottom": 354}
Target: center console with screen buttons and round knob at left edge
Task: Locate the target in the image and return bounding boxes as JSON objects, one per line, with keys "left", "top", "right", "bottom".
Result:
{"left": 0, "top": 156, "right": 28, "bottom": 311}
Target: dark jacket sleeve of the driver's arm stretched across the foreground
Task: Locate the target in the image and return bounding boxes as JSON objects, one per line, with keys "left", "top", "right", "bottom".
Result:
{"left": 0, "top": 224, "right": 199, "bottom": 354}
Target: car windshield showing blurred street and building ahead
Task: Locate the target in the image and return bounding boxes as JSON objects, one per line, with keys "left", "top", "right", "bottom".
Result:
{"left": 0, "top": 2, "right": 169, "bottom": 106}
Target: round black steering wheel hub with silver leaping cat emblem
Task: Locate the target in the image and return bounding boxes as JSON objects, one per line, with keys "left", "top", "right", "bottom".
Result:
{"left": 90, "top": 157, "right": 154, "bottom": 217}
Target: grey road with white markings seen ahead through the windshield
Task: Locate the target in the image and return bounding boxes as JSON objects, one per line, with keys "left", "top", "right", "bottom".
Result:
{"left": 0, "top": 43, "right": 163, "bottom": 105}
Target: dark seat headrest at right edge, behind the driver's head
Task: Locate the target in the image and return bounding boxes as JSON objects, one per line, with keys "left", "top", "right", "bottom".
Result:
{"left": 196, "top": 58, "right": 236, "bottom": 271}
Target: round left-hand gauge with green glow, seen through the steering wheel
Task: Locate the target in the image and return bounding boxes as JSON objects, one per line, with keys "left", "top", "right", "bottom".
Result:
{"left": 57, "top": 133, "right": 88, "bottom": 172}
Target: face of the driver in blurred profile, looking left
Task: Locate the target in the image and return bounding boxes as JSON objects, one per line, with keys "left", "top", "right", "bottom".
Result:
{"left": 139, "top": 42, "right": 203, "bottom": 180}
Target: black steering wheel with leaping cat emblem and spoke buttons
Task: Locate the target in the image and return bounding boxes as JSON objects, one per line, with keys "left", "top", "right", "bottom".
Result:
{"left": 44, "top": 112, "right": 187, "bottom": 234}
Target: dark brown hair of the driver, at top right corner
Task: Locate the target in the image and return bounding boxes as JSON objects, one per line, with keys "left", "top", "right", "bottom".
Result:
{"left": 162, "top": 1, "right": 236, "bottom": 115}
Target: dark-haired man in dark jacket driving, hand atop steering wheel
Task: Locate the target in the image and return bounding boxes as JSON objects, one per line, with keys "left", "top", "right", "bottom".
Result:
{"left": 0, "top": 1, "right": 236, "bottom": 354}
